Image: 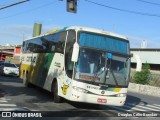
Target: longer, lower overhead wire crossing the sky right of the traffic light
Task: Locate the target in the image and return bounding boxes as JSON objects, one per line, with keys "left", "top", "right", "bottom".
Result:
{"left": 85, "top": 0, "right": 160, "bottom": 17}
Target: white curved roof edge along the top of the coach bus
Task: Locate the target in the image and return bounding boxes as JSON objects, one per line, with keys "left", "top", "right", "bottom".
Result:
{"left": 25, "top": 26, "right": 128, "bottom": 41}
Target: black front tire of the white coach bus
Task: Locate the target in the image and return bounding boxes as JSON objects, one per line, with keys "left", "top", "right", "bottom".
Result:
{"left": 52, "top": 82, "right": 62, "bottom": 103}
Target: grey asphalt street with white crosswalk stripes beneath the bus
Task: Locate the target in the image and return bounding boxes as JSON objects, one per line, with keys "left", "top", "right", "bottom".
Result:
{"left": 0, "top": 76, "right": 160, "bottom": 117}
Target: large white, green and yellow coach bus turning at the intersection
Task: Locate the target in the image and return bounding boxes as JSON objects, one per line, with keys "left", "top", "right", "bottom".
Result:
{"left": 20, "top": 26, "right": 130, "bottom": 106}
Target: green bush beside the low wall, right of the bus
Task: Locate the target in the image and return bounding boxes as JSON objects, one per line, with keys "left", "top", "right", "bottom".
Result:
{"left": 133, "top": 63, "right": 151, "bottom": 85}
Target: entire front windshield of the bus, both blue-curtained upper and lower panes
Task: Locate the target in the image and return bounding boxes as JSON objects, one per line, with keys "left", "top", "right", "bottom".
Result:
{"left": 75, "top": 32, "right": 130, "bottom": 86}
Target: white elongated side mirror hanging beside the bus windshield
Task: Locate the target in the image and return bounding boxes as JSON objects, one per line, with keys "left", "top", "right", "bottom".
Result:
{"left": 71, "top": 42, "right": 79, "bottom": 62}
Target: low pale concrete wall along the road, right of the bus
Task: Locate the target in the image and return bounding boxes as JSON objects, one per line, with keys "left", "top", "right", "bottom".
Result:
{"left": 128, "top": 83, "right": 160, "bottom": 97}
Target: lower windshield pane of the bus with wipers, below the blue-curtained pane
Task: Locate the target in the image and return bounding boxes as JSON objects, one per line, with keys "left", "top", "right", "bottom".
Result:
{"left": 75, "top": 48, "right": 129, "bottom": 86}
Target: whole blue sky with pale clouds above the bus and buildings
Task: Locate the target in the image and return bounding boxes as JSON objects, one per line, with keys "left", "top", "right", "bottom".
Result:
{"left": 0, "top": 0, "right": 160, "bottom": 48}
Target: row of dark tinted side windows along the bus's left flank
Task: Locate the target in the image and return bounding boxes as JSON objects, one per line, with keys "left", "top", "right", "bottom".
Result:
{"left": 23, "top": 32, "right": 66, "bottom": 53}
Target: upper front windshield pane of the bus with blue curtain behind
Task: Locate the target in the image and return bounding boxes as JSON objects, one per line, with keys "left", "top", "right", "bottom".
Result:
{"left": 79, "top": 32, "right": 129, "bottom": 54}
